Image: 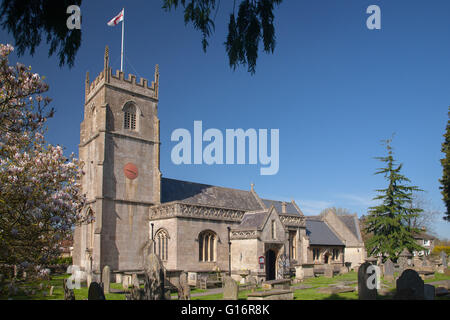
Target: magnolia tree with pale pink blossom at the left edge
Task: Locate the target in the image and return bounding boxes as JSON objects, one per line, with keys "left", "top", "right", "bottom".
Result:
{"left": 0, "top": 44, "right": 90, "bottom": 268}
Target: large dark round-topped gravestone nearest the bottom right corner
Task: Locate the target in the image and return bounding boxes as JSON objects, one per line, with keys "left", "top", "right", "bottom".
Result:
{"left": 394, "top": 269, "right": 425, "bottom": 300}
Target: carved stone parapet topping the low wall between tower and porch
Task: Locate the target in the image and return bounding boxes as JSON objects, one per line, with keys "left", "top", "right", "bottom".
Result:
{"left": 149, "top": 202, "right": 245, "bottom": 222}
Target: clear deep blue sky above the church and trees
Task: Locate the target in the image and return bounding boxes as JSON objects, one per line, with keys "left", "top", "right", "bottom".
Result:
{"left": 0, "top": 0, "right": 450, "bottom": 238}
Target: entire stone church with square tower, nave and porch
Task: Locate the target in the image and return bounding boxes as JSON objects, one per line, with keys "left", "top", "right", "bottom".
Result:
{"left": 73, "top": 47, "right": 366, "bottom": 280}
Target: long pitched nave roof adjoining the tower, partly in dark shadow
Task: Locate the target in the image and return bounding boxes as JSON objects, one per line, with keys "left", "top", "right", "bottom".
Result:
{"left": 161, "top": 178, "right": 264, "bottom": 211}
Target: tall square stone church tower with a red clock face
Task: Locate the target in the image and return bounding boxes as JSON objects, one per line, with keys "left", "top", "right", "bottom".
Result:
{"left": 73, "top": 47, "right": 161, "bottom": 273}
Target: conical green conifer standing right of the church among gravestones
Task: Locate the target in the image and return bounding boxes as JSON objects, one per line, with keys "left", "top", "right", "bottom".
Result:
{"left": 364, "top": 139, "right": 423, "bottom": 260}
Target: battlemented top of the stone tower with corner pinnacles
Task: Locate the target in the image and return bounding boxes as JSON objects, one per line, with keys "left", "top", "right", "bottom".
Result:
{"left": 85, "top": 46, "right": 159, "bottom": 102}
